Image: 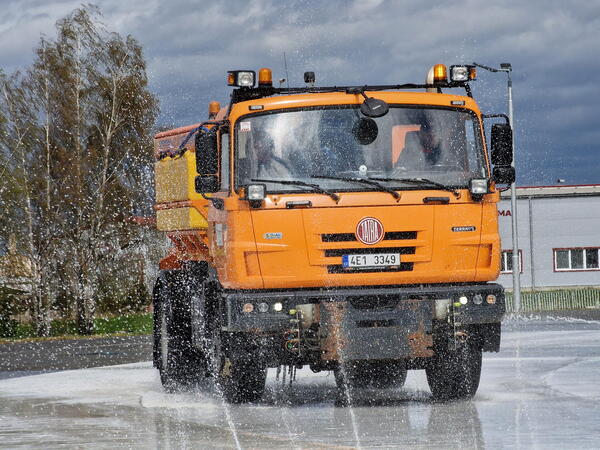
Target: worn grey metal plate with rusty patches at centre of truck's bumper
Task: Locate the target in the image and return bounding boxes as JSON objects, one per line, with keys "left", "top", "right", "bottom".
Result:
{"left": 320, "top": 299, "right": 433, "bottom": 361}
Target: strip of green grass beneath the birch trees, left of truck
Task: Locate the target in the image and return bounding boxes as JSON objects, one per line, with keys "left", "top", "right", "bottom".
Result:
{"left": 0, "top": 313, "right": 152, "bottom": 340}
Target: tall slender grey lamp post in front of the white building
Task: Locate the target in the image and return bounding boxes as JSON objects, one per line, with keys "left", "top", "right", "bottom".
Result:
{"left": 473, "top": 63, "right": 521, "bottom": 312}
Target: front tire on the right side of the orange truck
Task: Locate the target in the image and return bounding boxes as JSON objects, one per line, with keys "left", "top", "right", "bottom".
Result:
{"left": 425, "top": 342, "right": 482, "bottom": 401}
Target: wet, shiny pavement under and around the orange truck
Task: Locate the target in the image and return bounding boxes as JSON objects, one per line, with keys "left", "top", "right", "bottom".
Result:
{"left": 0, "top": 318, "right": 600, "bottom": 448}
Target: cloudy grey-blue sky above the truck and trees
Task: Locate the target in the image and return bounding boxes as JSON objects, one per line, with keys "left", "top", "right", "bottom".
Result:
{"left": 0, "top": 0, "right": 600, "bottom": 185}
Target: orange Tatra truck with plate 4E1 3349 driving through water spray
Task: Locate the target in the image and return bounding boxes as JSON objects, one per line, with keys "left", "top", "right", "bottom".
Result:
{"left": 154, "top": 64, "right": 515, "bottom": 402}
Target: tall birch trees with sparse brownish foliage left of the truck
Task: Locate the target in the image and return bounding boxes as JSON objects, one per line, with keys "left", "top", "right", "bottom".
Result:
{"left": 0, "top": 6, "right": 158, "bottom": 333}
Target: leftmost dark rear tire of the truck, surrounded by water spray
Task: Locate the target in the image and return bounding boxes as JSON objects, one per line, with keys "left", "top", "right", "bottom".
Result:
{"left": 154, "top": 272, "right": 206, "bottom": 392}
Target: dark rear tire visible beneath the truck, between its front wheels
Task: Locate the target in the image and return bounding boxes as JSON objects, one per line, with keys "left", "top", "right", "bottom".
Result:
{"left": 334, "top": 360, "right": 406, "bottom": 389}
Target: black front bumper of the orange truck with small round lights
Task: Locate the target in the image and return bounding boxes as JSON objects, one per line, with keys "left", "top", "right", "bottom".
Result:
{"left": 222, "top": 283, "right": 506, "bottom": 334}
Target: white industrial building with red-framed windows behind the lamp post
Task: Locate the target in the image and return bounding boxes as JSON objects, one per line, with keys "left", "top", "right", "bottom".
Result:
{"left": 498, "top": 185, "right": 600, "bottom": 290}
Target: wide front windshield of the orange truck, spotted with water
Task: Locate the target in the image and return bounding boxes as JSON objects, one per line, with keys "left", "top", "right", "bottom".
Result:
{"left": 236, "top": 106, "right": 486, "bottom": 192}
